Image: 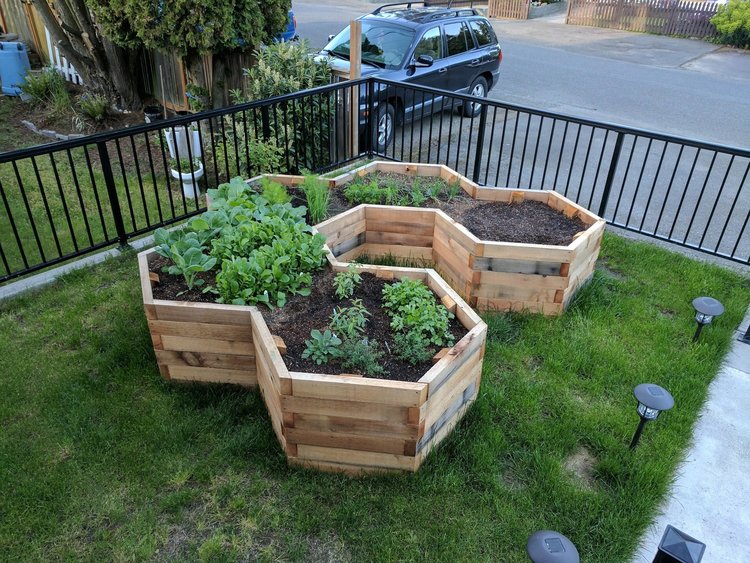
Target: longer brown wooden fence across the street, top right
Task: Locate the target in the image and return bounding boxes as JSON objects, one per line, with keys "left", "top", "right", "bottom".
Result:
{"left": 565, "top": 0, "right": 719, "bottom": 38}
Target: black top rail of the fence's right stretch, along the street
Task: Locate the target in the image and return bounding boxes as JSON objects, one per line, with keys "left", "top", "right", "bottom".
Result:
{"left": 373, "top": 77, "right": 750, "bottom": 158}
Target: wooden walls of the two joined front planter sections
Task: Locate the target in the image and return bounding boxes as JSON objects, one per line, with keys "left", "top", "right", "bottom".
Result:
{"left": 138, "top": 250, "right": 487, "bottom": 473}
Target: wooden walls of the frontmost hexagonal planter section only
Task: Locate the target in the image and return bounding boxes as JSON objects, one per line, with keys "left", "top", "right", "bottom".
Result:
{"left": 251, "top": 260, "right": 487, "bottom": 473}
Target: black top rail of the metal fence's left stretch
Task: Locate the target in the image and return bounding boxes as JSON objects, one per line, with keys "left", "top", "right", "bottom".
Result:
{"left": 0, "top": 78, "right": 372, "bottom": 164}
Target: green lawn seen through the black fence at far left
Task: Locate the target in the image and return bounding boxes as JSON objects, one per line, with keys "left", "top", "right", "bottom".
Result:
{"left": 0, "top": 100, "right": 206, "bottom": 275}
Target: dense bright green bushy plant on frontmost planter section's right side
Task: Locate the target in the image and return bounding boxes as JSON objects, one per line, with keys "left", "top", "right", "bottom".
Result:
{"left": 383, "top": 279, "right": 453, "bottom": 346}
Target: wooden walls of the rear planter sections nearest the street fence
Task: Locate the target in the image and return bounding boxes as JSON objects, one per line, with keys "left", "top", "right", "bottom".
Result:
{"left": 317, "top": 162, "right": 605, "bottom": 315}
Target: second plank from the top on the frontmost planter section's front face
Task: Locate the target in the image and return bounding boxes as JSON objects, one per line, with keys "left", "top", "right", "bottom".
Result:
{"left": 281, "top": 395, "right": 408, "bottom": 424}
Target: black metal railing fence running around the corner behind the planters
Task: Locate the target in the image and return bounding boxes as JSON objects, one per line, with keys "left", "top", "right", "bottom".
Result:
{"left": 0, "top": 78, "right": 750, "bottom": 282}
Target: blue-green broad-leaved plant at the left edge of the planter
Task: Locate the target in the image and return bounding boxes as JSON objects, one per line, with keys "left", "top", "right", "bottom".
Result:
{"left": 154, "top": 229, "right": 216, "bottom": 289}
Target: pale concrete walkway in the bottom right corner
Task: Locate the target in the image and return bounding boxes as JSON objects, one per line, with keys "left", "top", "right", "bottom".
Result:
{"left": 633, "top": 312, "right": 750, "bottom": 563}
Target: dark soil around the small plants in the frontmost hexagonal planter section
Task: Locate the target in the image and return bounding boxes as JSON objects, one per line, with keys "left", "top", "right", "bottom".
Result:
{"left": 261, "top": 269, "right": 466, "bottom": 381}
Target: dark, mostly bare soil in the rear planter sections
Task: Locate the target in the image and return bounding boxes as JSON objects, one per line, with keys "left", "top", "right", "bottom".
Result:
{"left": 338, "top": 173, "right": 587, "bottom": 246}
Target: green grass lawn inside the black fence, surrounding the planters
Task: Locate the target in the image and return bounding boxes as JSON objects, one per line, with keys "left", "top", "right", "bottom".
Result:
{"left": 0, "top": 235, "right": 748, "bottom": 563}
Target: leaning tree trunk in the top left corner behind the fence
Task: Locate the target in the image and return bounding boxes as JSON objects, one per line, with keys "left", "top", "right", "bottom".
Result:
{"left": 32, "top": 0, "right": 142, "bottom": 110}
